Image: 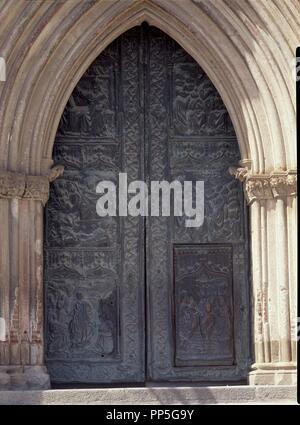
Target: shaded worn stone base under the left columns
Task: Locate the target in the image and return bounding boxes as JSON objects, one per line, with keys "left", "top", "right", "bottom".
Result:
{"left": 0, "top": 366, "right": 50, "bottom": 390}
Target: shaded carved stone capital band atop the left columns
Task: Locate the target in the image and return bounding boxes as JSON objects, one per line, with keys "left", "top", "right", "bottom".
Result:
{"left": 0, "top": 165, "right": 64, "bottom": 206}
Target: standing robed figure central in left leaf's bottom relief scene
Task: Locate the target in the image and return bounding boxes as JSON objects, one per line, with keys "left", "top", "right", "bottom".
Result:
{"left": 69, "top": 292, "right": 93, "bottom": 348}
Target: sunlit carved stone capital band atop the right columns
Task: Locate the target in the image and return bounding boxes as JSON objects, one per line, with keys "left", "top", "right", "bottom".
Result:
{"left": 229, "top": 167, "right": 297, "bottom": 205}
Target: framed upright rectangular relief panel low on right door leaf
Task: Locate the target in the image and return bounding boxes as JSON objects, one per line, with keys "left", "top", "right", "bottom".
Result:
{"left": 174, "top": 245, "right": 234, "bottom": 366}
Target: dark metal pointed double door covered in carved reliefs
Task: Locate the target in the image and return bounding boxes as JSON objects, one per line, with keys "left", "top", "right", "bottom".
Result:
{"left": 44, "top": 24, "right": 250, "bottom": 384}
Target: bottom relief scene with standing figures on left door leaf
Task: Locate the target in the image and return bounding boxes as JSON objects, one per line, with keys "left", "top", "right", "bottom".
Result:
{"left": 46, "top": 282, "right": 118, "bottom": 361}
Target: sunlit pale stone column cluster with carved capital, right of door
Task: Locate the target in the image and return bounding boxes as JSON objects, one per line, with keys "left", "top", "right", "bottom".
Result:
{"left": 230, "top": 168, "right": 297, "bottom": 384}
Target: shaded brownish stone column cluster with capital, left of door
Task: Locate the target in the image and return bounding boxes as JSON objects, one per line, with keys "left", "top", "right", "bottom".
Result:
{"left": 0, "top": 167, "right": 63, "bottom": 389}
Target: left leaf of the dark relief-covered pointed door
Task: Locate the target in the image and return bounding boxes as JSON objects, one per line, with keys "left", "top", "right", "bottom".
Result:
{"left": 44, "top": 29, "right": 145, "bottom": 384}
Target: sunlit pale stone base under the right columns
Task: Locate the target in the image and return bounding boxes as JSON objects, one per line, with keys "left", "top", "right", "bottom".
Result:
{"left": 248, "top": 363, "right": 297, "bottom": 385}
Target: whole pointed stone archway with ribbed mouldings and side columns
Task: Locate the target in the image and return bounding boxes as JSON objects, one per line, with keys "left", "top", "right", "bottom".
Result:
{"left": 0, "top": 0, "right": 300, "bottom": 388}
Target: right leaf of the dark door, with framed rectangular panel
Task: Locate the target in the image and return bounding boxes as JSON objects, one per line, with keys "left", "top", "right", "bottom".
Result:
{"left": 146, "top": 27, "right": 249, "bottom": 382}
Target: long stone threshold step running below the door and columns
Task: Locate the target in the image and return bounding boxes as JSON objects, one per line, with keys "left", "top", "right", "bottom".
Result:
{"left": 0, "top": 385, "right": 297, "bottom": 405}
